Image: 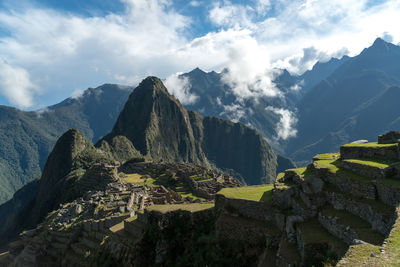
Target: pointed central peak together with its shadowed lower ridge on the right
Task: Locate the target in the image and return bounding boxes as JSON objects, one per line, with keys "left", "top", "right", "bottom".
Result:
{"left": 98, "top": 77, "right": 277, "bottom": 184}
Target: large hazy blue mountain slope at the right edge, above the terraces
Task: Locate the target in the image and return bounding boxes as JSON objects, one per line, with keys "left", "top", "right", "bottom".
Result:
{"left": 286, "top": 38, "right": 400, "bottom": 161}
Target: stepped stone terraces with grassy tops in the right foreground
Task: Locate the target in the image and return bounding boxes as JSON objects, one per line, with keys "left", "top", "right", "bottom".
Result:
{"left": 212, "top": 133, "right": 400, "bottom": 266}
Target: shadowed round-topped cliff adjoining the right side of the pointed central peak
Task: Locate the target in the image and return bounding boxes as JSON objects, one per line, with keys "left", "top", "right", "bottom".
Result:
{"left": 198, "top": 117, "right": 277, "bottom": 184}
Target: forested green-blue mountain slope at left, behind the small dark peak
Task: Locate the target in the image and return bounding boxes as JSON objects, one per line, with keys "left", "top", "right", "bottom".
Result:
{"left": 0, "top": 84, "right": 133, "bottom": 203}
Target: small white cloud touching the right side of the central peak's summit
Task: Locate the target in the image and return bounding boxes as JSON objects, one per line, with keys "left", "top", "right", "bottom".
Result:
{"left": 164, "top": 73, "right": 199, "bottom": 105}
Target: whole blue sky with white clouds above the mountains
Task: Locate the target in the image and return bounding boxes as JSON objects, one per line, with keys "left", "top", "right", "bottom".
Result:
{"left": 0, "top": 0, "right": 400, "bottom": 110}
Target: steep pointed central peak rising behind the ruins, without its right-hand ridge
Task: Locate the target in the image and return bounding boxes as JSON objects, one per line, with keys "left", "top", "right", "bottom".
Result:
{"left": 104, "top": 77, "right": 207, "bottom": 163}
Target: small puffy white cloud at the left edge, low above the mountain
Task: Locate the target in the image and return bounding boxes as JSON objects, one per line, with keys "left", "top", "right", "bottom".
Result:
{"left": 0, "top": 60, "right": 39, "bottom": 108}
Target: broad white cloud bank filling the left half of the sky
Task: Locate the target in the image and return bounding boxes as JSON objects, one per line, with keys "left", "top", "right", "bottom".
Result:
{"left": 0, "top": 0, "right": 190, "bottom": 108}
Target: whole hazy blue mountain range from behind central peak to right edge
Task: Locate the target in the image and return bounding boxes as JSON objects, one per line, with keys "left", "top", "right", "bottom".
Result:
{"left": 181, "top": 38, "right": 400, "bottom": 165}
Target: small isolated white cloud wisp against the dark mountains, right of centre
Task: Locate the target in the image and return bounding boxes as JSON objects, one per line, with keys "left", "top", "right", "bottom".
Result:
{"left": 266, "top": 107, "right": 297, "bottom": 140}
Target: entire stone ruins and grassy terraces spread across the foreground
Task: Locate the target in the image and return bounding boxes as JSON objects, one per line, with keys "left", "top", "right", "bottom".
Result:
{"left": 0, "top": 132, "right": 400, "bottom": 266}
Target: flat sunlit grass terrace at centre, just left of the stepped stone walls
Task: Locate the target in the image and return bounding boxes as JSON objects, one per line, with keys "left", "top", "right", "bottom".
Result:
{"left": 218, "top": 184, "right": 274, "bottom": 202}
